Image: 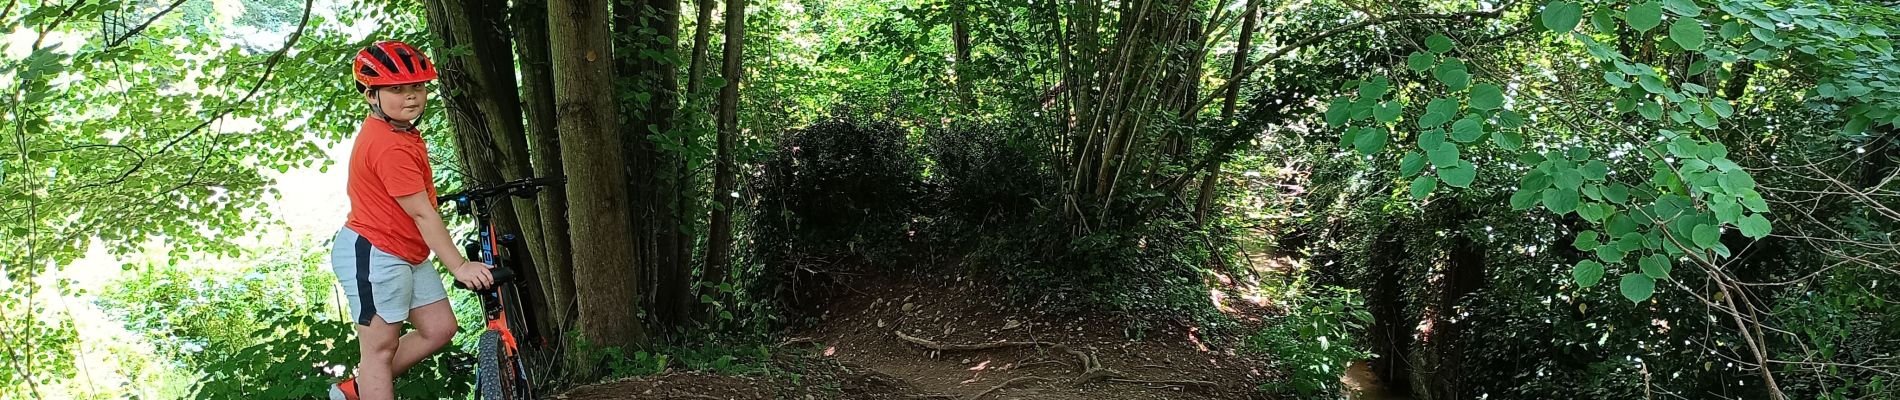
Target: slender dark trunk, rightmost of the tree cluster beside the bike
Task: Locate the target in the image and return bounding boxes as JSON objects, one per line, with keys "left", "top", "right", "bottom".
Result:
{"left": 705, "top": 0, "right": 745, "bottom": 317}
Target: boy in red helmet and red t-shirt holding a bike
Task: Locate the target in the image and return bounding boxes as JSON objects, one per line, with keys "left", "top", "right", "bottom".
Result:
{"left": 331, "top": 42, "right": 492, "bottom": 400}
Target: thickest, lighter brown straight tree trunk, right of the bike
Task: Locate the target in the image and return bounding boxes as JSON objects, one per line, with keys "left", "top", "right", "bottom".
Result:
{"left": 547, "top": 0, "right": 646, "bottom": 347}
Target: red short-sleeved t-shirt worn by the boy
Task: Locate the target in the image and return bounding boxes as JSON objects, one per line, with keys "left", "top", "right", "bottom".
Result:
{"left": 344, "top": 118, "right": 435, "bottom": 264}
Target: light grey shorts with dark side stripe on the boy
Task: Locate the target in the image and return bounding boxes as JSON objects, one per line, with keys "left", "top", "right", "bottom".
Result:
{"left": 331, "top": 227, "right": 448, "bottom": 324}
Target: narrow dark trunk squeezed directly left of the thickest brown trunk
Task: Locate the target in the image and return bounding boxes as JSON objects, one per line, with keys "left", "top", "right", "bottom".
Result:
{"left": 511, "top": 0, "right": 574, "bottom": 334}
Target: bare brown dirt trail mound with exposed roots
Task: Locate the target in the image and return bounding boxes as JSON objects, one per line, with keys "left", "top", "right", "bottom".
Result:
{"left": 562, "top": 279, "right": 1271, "bottom": 400}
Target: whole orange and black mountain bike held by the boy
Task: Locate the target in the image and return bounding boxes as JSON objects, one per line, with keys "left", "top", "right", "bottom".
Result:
{"left": 435, "top": 178, "right": 566, "bottom": 400}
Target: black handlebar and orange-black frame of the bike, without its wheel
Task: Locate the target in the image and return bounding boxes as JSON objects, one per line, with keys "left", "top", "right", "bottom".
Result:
{"left": 437, "top": 178, "right": 564, "bottom": 398}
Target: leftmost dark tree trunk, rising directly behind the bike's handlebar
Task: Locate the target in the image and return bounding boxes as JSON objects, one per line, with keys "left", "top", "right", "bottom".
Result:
{"left": 428, "top": 0, "right": 555, "bottom": 337}
